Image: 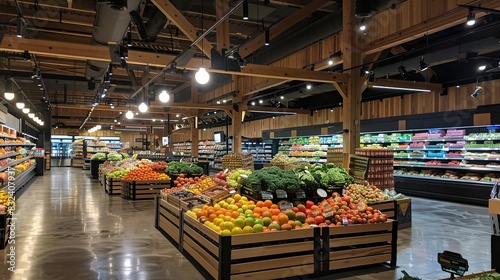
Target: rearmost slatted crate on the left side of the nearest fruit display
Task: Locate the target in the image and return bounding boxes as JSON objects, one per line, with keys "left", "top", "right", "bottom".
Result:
{"left": 155, "top": 197, "right": 182, "bottom": 246}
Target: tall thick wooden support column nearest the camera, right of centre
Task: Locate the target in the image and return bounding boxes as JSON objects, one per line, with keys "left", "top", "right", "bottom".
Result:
{"left": 341, "top": 0, "right": 363, "bottom": 167}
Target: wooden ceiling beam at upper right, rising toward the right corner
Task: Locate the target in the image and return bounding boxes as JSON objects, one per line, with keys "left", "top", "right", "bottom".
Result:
{"left": 364, "top": 0, "right": 500, "bottom": 54}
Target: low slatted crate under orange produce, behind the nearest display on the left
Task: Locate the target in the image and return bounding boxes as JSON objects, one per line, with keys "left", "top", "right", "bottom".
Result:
{"left": 121, "top": 180, "right": 171, "bottom": 200}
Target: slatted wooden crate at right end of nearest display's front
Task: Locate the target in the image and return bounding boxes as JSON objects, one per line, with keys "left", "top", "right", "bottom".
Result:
{"left": 322, "top": 220, "right": 398, "bottom": 275}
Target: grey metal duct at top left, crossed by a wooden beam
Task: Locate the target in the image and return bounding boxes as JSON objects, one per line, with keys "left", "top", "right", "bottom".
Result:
{"left": 85, "top": 0, "right": 142, "bottom": 81}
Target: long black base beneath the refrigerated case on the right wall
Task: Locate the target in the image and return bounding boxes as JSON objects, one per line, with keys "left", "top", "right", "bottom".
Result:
{"left": 394, "top": 176, "right": 492, "bottom": 206}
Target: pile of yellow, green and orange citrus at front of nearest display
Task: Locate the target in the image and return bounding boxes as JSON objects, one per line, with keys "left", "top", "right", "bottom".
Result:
{"left": 186, "top": 194, "right": 387, "bottom": 236}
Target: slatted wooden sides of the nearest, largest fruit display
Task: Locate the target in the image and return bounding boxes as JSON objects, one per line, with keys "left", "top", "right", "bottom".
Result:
{"left": 155, "top": 197, "right": 397, "bottom": 279}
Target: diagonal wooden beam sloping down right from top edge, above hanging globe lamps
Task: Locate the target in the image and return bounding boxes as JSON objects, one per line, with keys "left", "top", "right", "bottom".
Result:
{"left": 151, "top": 0, "right": 213, "bottom": 59}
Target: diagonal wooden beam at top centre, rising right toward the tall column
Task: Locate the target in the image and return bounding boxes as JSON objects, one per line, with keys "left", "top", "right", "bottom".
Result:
{"left": 239, "top": 0, "right": 329, "bottom": 57}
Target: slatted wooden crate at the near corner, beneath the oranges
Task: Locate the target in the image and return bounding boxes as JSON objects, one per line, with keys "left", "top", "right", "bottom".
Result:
{"left": 181, "top": 214, "right": 321, "bottom": 280}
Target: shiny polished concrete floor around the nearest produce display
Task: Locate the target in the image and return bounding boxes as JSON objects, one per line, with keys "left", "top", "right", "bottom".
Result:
{"left": 0, "top": 168, "right": 490, "bottom": 280}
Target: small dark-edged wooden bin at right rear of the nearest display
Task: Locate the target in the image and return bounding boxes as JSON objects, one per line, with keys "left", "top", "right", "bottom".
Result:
{"left": 369, "top": 198, "right": 411, "bottom": 229}
